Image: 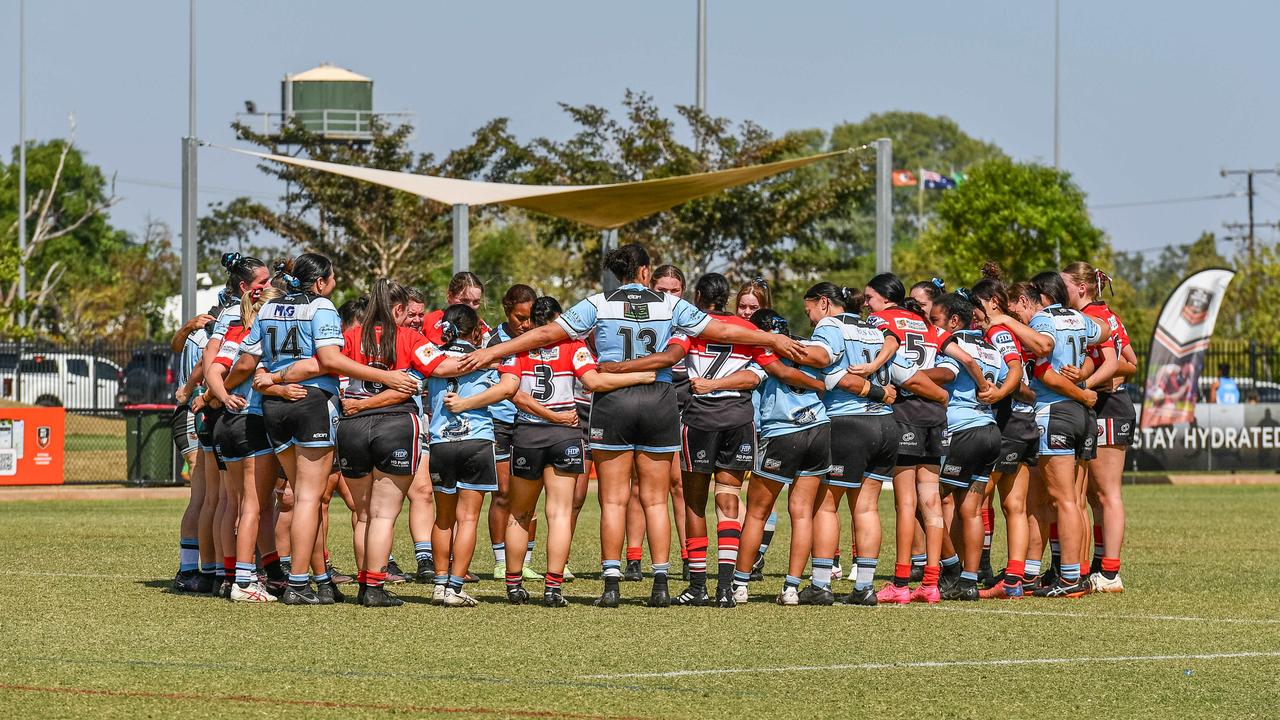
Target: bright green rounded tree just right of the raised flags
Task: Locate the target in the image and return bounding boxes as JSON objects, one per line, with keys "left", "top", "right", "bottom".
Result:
{"left": 922, "top": 158, "right": 1110, "bottom": 279}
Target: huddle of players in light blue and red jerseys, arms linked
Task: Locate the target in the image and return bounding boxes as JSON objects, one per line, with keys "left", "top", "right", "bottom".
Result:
{"left": 165, "top": 245, "right": 1137, "bottom": 607}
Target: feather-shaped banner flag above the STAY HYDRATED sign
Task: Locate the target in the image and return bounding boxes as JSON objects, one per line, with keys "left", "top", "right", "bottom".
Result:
{"left": 1139, "top": 268, "right": 1235, "bottom": 428}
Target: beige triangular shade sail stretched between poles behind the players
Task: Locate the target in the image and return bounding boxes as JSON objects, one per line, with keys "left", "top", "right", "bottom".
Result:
{"left": 210, "top": 145, "right": 856, "bottom": 229}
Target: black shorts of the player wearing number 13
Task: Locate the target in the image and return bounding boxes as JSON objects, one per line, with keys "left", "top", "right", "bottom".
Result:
{"left": 589, "top": 383, "right": 680, "bottom": 452}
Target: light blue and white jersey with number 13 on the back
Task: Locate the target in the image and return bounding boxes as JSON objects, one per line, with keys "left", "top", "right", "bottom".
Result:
{"left": 556, "top": 283, "right": 712, "bottom": 383}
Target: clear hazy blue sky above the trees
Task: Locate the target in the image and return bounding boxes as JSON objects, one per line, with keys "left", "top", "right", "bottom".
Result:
{"left": 0, "top": 0, "right": 1280, "bottom": 260}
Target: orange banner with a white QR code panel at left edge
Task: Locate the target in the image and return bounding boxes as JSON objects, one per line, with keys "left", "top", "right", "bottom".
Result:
{"left": 0, "top": 407, "right": 67, "bottom": 486}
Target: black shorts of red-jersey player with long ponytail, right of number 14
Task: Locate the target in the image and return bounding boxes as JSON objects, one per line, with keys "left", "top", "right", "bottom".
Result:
{"left": 337, "top": 413, "right": 422, "bottom": 478}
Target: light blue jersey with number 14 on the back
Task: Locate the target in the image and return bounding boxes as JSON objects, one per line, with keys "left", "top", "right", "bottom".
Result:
{"left": 241, "top": 292, "right": 343, "bottom": 395}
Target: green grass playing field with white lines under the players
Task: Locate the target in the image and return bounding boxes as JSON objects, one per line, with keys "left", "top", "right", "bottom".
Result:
{"left": 0, "top": 487, "right": 1280, "bottom": 719}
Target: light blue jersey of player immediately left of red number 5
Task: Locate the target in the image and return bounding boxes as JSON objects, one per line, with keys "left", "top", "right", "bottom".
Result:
{"left": 813, "top": 313, "right": 916, "bottom": 418}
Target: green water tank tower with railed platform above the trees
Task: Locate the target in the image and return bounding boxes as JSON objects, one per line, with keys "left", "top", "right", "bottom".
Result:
{"left": 236, "top": 63, "right": 415, "bottom": 142}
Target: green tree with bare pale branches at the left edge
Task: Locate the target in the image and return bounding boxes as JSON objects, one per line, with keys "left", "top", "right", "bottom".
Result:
{"left": 0, "top": 131, "right": 127, "bottom": 334}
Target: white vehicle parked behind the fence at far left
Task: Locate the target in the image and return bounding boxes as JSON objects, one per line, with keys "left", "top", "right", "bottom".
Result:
{"left": 0, "top": 352, "right": 120, "bottom": 410}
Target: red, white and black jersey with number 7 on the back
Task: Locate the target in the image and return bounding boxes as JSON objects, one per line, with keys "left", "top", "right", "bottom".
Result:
{"left": 667, "top": 315, "right": 778, "bottom": 430}
